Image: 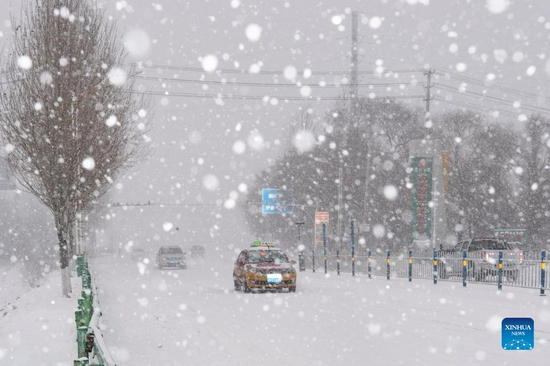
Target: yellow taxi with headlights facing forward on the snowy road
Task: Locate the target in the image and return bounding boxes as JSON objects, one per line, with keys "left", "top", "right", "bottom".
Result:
{"left": 233, "top": 241, "right": 296, "bottom": 293}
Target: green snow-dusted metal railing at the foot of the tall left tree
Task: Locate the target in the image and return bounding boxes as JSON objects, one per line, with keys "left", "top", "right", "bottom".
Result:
{"left": 74, "top": 255, "right": 116, "bottom": 366}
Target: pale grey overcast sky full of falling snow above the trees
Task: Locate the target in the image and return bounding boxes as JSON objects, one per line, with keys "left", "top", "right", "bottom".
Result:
{"left": 0, "top": 0, "right": 550, "bottom": 247}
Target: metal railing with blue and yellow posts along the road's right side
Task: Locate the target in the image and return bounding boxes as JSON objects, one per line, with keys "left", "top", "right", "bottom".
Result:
{"left": 300, "top": 250, "right": 550, "bottom": 295}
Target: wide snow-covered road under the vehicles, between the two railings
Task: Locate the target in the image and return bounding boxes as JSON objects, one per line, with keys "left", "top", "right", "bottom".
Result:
{"left": 91, "top": 252, "right": 550, "bottom": 366}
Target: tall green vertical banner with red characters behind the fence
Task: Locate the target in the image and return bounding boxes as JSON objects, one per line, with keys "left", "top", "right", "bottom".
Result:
{"left": 409, "top": 157, "right": 433, "bottom": 241}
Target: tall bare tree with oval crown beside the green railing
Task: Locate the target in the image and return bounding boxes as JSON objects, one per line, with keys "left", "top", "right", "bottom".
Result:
{"left": 0, "top": 0, "right": 149, "bottom": 297}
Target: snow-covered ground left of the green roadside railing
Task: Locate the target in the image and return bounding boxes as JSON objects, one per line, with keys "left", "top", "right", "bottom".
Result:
{"left": 0, "top": 265, "right": 81, "bottom": 366}
